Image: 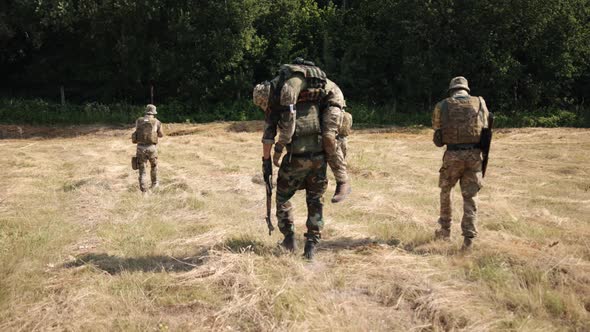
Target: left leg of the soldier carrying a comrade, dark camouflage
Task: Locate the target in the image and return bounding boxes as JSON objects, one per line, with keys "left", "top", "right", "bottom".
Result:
{"left": 276, "top": 155, "right": 307, "bottom": 236}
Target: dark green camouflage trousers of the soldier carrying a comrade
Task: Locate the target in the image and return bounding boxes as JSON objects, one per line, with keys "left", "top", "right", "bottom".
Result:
{"left": 276, "top": 154, "right": 328, "bottom": 242}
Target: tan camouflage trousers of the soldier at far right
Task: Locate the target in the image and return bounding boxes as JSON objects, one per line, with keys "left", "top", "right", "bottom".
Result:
{"left": 438, "top": 149, "right": 483, "bottom": 238}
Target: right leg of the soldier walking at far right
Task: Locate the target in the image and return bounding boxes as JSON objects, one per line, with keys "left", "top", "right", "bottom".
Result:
{"left": 460, "top": 153, "right": 482, "bottom": 244}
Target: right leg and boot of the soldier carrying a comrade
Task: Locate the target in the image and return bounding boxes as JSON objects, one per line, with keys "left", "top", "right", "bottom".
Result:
{"left": 303, "top": 159, "right": 328, "bottom": 259}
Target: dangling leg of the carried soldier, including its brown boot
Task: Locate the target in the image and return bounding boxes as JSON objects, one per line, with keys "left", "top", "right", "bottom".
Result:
{"left": 322, "top": 107, "right": 351, "bottom": 203}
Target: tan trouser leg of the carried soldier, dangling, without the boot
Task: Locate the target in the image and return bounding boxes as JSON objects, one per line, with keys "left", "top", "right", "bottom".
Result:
{"left": 322, "top": 106, "right": 348, "bottom": 183}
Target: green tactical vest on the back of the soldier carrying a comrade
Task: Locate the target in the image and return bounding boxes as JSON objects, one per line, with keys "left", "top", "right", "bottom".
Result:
{"left": 288, "top": 102, "right": 324, "bottom": 154}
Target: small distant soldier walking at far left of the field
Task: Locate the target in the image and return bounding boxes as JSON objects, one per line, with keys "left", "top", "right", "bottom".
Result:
{"left": 132, "top": 104, "right": 164, "bottom": 192}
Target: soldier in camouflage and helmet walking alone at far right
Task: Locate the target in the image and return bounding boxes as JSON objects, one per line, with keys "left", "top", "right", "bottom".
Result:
{"left": 432, "top": 76, "right": 491, "bottom": 250}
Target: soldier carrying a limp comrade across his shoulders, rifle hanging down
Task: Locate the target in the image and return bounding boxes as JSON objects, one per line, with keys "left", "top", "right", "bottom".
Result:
{"left": 253, "top": 59, "right": 336, "bottom": 259}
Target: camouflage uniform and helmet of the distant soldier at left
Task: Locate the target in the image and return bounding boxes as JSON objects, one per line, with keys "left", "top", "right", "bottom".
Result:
{"left": 134, "top": 105, "right": 164, "bottom": 192}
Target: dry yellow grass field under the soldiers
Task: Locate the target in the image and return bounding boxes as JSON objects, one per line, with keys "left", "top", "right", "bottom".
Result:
{"left": 0, "top": 122, "right": 590, "bottom": 331}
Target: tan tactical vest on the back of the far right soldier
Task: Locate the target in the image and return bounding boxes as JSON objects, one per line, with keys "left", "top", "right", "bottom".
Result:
{"left": 441, "top": 96, "right": 484, "bottom": 144}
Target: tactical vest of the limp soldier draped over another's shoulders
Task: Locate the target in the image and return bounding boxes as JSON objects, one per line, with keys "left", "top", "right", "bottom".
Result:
{"left": 275, "top": 64, "right": 328, "bottom": 102}
